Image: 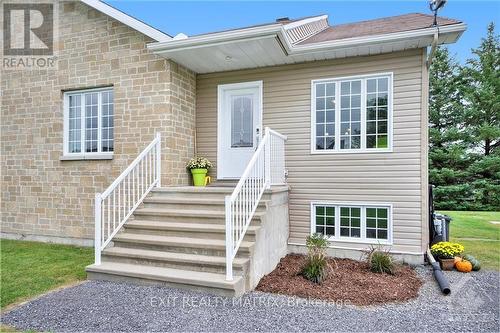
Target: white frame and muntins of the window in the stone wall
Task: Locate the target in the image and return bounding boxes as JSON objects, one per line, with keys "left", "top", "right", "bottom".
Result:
{"left": 60, "top": 86, "right": 115, "bottom": 160}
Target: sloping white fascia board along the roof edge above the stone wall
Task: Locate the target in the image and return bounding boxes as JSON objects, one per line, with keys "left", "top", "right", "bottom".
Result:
{"left": 80, "top": 0, "right": 172, "bottom": 42}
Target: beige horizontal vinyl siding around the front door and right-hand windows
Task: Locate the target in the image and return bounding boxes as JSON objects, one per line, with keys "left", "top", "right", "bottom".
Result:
{"left": 196, "top": 49, "right": 426, "bottom": 253}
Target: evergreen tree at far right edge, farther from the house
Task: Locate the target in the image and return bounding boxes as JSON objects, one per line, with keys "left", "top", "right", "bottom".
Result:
{"left": 462, "top": 23, "right": 500, "bottom": 210}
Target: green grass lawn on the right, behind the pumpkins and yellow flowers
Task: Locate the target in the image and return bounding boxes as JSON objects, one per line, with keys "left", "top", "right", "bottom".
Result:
{"left": 440, "top": 211, "right": 500, "bottom": 270}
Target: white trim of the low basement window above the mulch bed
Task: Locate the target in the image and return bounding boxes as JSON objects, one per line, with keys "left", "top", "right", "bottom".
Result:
{"left": 310, "top": 201, "right": 393, "bottom": 245}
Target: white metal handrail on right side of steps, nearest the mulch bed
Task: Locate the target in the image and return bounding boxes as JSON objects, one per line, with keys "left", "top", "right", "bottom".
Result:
{"left": 225, "top": 127, "right": 287, "bottom": 280}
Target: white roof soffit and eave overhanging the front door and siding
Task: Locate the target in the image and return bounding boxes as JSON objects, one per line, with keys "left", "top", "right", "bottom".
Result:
{"left": 148, "top": 16, "right": 467, "bottom": 73}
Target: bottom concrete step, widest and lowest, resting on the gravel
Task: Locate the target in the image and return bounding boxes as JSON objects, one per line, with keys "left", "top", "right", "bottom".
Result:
{"left": 86, "top": 262, "right": 244, "bottom": 296}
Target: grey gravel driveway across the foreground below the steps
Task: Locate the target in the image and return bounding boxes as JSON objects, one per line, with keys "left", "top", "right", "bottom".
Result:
{"left": 2, "top": 267, "right": 500, "bottom": 332}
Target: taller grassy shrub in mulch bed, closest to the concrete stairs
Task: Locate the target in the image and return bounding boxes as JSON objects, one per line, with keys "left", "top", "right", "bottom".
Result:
{"left": 301, "top": 234, "right": 330, "bottom": 284}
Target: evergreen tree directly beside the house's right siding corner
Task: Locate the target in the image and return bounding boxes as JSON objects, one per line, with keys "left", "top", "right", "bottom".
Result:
{"left": 429, "top": 48, "right": 473, "bottom": 209}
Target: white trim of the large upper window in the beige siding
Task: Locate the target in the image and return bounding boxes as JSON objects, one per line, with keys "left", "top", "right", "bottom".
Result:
{"left": 310, "top": 72, "right": 394, "bottom": 154}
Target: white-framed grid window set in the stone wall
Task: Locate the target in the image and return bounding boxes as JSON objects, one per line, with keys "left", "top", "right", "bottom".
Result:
{"left": 62, "top": 88, "right": 114, "bottom": 159}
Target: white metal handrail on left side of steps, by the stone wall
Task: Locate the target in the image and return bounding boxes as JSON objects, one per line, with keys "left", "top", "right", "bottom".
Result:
{"left": 94, "top": 133, "right": 161, "bottom": 265}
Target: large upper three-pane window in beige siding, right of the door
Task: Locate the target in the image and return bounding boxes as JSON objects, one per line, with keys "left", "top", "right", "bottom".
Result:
{"left": 311, "top": 73, "right": 392, "bottom": 154}
